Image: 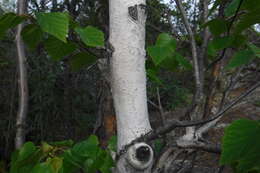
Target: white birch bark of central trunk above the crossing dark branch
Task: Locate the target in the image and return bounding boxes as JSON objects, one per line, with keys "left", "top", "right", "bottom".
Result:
{"left": 109, "top": 0, "right": 151, "bottom": 150}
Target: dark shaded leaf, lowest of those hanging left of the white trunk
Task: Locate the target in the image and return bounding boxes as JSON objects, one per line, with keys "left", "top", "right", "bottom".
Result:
{"left": 70, "top": 52, "right": 97, "bottom": 71}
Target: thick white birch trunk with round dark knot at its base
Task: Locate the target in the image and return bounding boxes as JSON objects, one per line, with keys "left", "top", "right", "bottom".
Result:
{"left": 109, "top": 0, "right": 153, "bottom": 173}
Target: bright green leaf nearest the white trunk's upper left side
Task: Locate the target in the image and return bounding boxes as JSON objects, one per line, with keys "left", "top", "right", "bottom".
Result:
{"left": 75, "top": 26, "right": 104, "bottom": 47}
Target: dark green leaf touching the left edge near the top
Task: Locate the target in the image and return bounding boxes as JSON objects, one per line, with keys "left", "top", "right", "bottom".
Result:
{"left": 0, "top": 13, "right": 26, "bottom": 39}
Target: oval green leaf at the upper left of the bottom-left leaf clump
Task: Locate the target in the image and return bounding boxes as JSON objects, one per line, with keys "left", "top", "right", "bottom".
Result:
{"left": 18, "top": 142, "right": 36, "bottom": 161}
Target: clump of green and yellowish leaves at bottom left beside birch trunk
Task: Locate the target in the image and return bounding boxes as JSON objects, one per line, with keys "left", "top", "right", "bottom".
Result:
{"left": 5, "top": 135, "right": 116, "bottom": 173}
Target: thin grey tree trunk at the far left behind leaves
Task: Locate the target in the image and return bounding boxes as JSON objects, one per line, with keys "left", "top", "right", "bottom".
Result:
{"left": 15, "top": 0, "right": 28, "bottom": 149}
